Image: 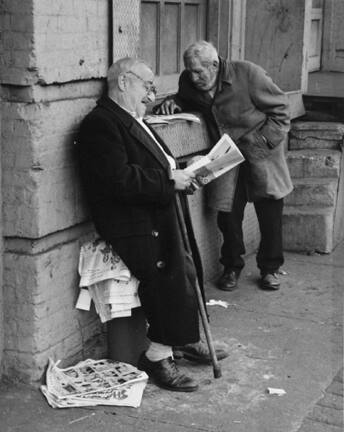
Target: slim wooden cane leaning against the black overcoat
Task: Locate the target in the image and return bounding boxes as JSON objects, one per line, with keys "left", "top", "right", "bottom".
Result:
{"left": 176, "top": 195, "right": 222, "bottom": 378}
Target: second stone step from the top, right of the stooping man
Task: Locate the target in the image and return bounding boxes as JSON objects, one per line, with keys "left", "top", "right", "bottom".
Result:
{"left": 288, "top": 149, "right": 342, "bottom": 178}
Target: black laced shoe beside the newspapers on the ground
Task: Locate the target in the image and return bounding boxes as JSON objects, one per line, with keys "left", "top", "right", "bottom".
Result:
{"left": 137, "top": 353, "right": 198, "bottom": 392}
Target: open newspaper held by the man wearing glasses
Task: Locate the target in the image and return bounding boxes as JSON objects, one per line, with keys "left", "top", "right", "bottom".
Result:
{"left": 185, "top": 134, "right": 245, "bottom": 189}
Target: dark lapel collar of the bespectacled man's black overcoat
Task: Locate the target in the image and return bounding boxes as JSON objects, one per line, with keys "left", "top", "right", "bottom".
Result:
{"left": 97, "top": 96, "right": 172, "bottom": 169}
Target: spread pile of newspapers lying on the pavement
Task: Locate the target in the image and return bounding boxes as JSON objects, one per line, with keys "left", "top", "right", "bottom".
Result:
{"left": 41, "top": 359, "right": 148, "bottom": 408}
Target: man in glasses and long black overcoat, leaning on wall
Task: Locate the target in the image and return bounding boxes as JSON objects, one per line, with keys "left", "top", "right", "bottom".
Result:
{"left": 77, "top": 58, "right": 227, "bottom": 391}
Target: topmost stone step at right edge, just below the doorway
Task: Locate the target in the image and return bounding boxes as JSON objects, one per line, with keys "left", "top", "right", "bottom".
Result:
{"left": 289, "top": 121, "right": 344, "bottom": 150}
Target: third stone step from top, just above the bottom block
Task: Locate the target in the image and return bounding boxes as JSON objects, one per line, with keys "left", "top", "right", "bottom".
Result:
{"left": 285, "top": 177, "right": 338, "bottom": 208}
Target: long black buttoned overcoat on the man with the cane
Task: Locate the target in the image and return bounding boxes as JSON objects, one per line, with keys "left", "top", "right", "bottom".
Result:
{"left": 77, "top": 97, "right": 202, "bottom": 345}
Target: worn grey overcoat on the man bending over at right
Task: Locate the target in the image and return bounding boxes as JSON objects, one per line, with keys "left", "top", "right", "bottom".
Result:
{"left": 175, "top": 57, "right": 293, "bottom": 211}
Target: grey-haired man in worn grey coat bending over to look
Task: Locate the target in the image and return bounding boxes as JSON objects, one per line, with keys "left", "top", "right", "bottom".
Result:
{"left": 156, "top": 41, "right": 293, "bottom": 291}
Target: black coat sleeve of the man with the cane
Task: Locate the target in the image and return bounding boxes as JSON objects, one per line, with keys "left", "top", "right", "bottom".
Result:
{"left": 77, "top": 110, "right": 175, "bottom": 205}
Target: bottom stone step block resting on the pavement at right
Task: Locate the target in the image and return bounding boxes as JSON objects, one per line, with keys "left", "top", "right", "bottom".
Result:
{"left": 283, "top": 206, "right": 334, "bottom": 253}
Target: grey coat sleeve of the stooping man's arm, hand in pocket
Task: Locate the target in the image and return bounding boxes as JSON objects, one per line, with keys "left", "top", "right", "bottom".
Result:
{"left": 249, "top": 64, "right": 290, "bottom": 148}
